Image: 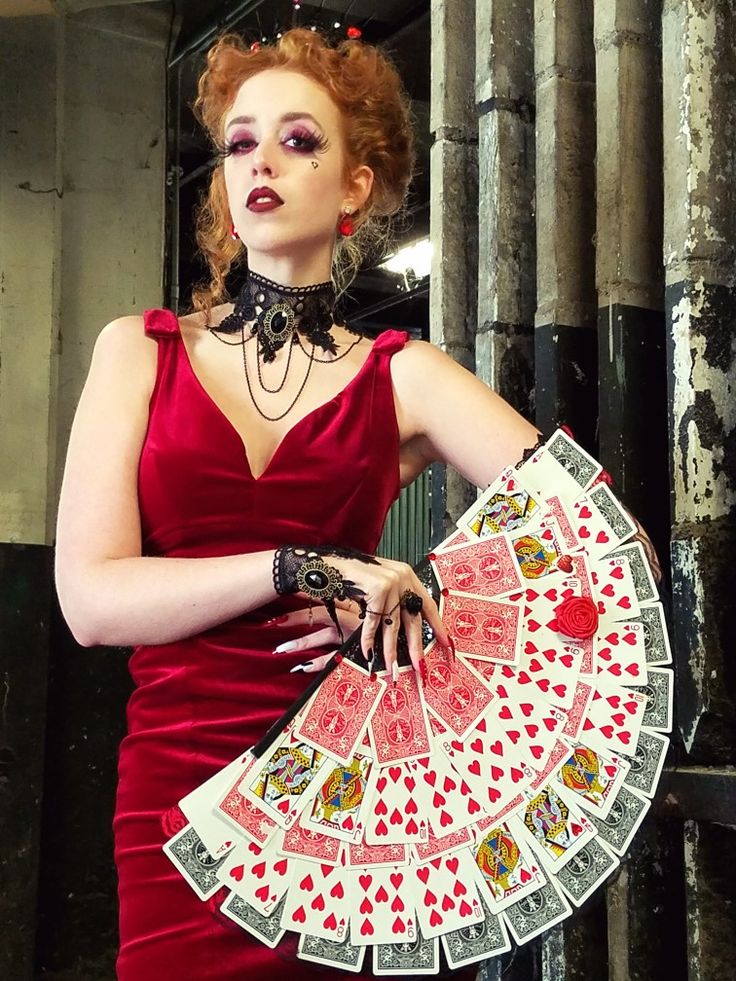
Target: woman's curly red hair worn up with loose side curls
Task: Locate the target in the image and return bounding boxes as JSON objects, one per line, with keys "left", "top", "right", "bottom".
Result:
{"left": 192, "top": 28, "right": 414, "bottom": 323}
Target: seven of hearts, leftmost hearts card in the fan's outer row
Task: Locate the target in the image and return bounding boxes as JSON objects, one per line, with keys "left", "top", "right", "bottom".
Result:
{"left": 217, "top": 831, "right": 294, "bottom": 916}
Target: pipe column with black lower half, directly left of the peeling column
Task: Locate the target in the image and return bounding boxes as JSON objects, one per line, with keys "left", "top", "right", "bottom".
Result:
{"left": 594, "top": 0, "right": 669, "bottom": 553}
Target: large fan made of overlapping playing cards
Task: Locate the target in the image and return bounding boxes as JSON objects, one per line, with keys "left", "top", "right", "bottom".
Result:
{"left": 165, "top": 430, "right": 673, "bottom": 975}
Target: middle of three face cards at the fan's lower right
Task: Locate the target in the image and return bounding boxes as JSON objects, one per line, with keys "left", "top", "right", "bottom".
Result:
{"left": 507, "top": 784, "right": 596, "bottom": 872}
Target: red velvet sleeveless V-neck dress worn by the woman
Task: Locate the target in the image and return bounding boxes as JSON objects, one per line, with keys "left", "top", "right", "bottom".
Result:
{"left": 113, "top": 310, "right": 474, "bottom": 981}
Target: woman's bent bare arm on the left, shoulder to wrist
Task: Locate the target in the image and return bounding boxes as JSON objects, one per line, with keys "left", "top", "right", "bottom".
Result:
{"left": 56, "top": 317, "right": 276, "bottom": 646}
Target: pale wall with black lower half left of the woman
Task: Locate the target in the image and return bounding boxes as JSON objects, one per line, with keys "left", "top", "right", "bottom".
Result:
{"left": 0, "top": 4, "right": 170, "bottom": 981}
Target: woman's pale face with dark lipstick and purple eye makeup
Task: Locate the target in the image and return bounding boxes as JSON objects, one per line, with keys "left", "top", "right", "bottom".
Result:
{"left": 224, "top": 68, "right": 367, "bottom": 276}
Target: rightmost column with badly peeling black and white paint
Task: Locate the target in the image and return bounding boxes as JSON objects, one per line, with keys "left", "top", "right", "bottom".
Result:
{"left": 662, "top": 0, "right": 736, "bottom": 765}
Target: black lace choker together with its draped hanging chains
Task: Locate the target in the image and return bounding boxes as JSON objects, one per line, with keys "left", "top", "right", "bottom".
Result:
{"left": 208, "top": 271, "right": 363, "bottom": 422}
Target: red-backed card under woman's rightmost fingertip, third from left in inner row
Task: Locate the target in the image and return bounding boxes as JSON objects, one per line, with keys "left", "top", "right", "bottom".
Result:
{"left": 423, "top": 644, "right": 493, "bottom": 738}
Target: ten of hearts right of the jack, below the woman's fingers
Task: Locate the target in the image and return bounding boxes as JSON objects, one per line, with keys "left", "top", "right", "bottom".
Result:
{"left": 365, "top": 763, "right": 429, "bottom": 845}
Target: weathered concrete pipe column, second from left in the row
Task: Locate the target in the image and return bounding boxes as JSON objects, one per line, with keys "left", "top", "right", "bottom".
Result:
{"left": 475, "top": 0, "right": 536, "bottom": 419}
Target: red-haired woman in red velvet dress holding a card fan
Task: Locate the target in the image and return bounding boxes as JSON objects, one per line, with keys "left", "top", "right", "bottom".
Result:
{"left": 57, "top": 30, "right": 644, "bottom": 981}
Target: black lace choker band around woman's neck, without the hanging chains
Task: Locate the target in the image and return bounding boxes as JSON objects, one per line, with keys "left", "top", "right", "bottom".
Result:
{"left": 208, "top": 272, "right": 344, "bottom": 362}
